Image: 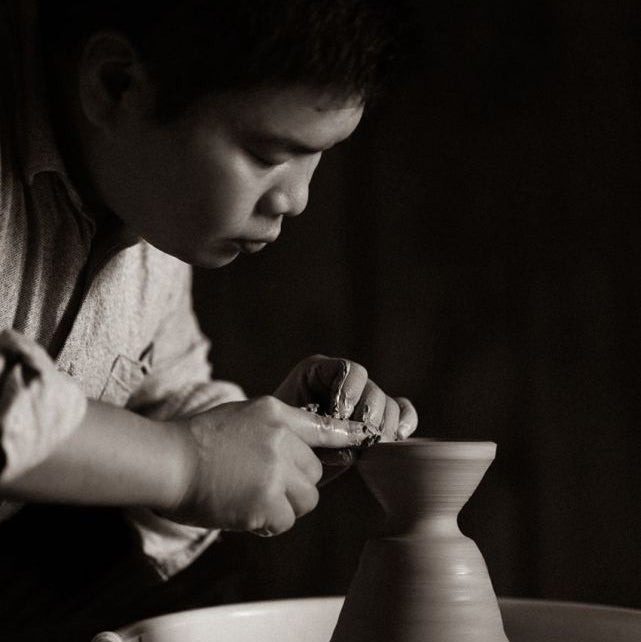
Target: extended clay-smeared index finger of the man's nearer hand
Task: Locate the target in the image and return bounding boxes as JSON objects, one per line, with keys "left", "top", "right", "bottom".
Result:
{"left": 287, "top": 408, "right": 368, "bottom": 448}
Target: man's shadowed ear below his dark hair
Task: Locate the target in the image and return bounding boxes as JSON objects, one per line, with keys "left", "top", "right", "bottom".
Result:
{"left": 78, "top": 32, "right": 152, "bottom": 129}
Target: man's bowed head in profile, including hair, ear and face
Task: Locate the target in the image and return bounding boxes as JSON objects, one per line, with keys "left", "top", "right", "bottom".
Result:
{"left": 41, "top": 0, "right": 400, "bottom": 267}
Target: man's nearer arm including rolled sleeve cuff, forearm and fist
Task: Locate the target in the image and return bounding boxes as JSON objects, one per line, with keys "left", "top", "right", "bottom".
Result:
{"left": 0, "top": 312, "right": 362, "bottom": 532}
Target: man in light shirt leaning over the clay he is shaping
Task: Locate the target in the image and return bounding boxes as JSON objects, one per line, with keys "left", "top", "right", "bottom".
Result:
{"left": 0, "top": 0, "right": 417, "bottom": 632}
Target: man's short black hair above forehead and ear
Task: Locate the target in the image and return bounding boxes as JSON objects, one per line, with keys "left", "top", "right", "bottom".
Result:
{"left": 40, "top": 0, "right": 402, "bottom": 120}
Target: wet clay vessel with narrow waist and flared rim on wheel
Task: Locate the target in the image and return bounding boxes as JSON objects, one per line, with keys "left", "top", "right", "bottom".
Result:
{"left": 331, "top": 439, "right": 507, "bottom": 642}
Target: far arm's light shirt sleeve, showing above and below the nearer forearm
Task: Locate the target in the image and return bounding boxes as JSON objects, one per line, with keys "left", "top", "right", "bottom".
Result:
{"left": 127, "top": 266, "right": 246, "bottom": 579}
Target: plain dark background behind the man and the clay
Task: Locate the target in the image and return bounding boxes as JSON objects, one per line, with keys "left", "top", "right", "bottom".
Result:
{"left": 195, "top": 0, "right": 641, "bottom": 607}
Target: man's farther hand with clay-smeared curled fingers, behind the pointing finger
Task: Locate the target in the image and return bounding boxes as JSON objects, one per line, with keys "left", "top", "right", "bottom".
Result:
{"left": 274, "top": 355, "right": 418, "bottom": 441}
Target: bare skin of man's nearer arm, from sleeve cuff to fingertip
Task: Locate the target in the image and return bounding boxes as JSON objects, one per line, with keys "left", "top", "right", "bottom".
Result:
{"left": 0, "top": 384, "right": 363, "bottom": 534}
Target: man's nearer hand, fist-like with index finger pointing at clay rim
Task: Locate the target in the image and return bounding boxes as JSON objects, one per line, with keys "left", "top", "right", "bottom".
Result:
{"left": 165, "top": 397, "right": 366, "bottom": 535}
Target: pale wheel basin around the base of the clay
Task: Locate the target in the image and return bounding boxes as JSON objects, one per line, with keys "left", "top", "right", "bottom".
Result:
{"left": 93, "top": 597, "right": 641, "bottom": 642}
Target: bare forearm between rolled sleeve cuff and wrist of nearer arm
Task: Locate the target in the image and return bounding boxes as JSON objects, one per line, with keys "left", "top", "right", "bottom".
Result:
{"left": 0, "top": 402, "right": 191, "bottom": 510}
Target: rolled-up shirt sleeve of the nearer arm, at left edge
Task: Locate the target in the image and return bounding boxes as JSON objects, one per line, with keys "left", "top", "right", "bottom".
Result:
{"left": 0, "top": 330, "right": 87, "bottom": 481}
